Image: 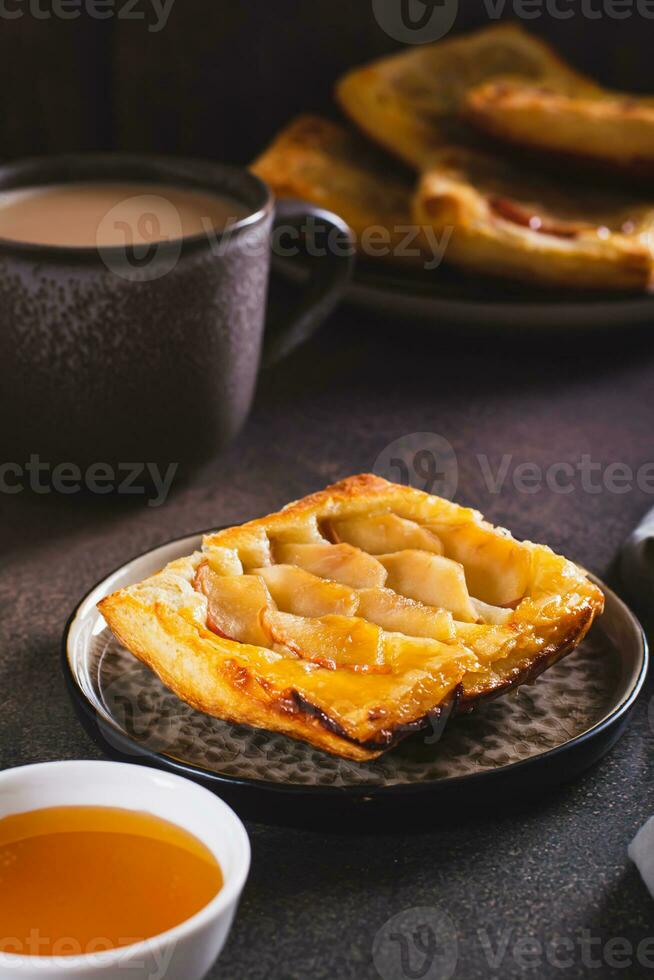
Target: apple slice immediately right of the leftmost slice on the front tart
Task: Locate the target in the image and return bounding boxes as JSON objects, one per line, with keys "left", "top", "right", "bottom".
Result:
{"left": 256, "top": 565, "right": 359, "bottom": 617}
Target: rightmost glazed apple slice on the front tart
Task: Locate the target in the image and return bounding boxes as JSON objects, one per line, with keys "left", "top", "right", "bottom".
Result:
{"left": 434, "top": 523, "right": 531, "bottom": 606}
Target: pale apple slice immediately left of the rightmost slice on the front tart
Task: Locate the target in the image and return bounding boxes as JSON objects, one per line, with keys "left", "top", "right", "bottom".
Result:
{"left": 379, "top": 550, "right": 478, "bottom": 623}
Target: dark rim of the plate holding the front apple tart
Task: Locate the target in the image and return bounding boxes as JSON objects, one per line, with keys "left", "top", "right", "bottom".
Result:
{"left": 61, "top": 525, "right": 649, "bottom": 801}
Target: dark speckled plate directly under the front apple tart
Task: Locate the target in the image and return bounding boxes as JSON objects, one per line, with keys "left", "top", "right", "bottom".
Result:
{"left": 63, "top": 535, "right": 647, "bottom": 819}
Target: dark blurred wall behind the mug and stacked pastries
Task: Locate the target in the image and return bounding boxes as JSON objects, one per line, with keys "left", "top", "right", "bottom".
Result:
{"left": 0, "top": 0, "right": 654, "bottom": 162}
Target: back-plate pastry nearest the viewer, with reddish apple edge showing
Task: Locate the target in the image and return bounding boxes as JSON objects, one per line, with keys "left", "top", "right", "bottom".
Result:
{"left": 414, "top": 147, "right": 654, "bottom": 291}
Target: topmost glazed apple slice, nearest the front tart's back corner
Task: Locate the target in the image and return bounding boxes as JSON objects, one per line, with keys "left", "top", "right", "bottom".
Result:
{"left": 329, "top": 513, "right": 443, "bottom": 555}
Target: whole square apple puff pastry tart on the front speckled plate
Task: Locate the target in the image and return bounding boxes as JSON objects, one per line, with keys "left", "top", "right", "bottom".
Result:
{"left": 99, "top": 475, "right": 603, "bottom": 760}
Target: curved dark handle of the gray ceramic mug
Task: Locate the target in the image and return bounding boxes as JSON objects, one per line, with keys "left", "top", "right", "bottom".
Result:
{"left": 261, "top": 200, "right": 354, "bottom": 368}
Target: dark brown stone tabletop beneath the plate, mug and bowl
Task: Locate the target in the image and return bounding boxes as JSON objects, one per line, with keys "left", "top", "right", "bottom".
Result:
{"left": 0, "top": 310, "right": 654, "bottom": 980}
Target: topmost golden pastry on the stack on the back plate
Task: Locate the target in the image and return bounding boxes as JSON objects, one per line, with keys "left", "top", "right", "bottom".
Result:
{"left": 465, "top": 78, "right": 654, "bottom": 177}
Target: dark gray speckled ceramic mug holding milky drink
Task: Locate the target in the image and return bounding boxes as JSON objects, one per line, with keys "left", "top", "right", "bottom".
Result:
{"left": 0, "top": 154, "right": 352, "bottom": 471}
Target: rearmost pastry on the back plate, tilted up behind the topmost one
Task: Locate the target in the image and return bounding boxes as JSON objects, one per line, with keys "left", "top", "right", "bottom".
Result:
{"left": 336, "top": 23, "right": 599, "bottom": 169}
